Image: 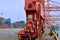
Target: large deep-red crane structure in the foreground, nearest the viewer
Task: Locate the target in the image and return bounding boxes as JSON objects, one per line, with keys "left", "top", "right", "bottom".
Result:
{"left": 18, "top": 0, "right": 44, "bottom": 40}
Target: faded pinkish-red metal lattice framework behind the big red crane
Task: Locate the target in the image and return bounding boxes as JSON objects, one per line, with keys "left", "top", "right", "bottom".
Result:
{"left": 45, "top": 0, "right": 60, "bottom": 25}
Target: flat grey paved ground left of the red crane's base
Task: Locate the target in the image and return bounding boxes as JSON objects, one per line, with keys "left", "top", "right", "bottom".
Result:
{"left": 0, "top": 28, "right": 23, "bottom": 40}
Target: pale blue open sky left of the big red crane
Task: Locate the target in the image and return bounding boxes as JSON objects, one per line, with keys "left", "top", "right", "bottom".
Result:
{"left": 0, "top": 0, "right": 26, "bottom": 22}
